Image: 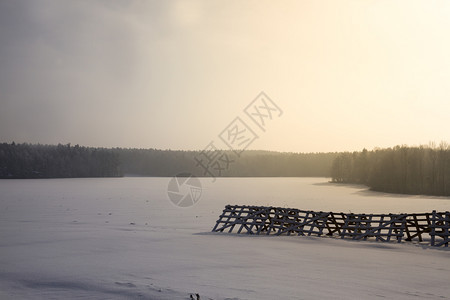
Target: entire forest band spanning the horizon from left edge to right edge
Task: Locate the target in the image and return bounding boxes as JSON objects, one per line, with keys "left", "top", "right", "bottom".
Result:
{"left": 0, "top": 142, "right": 450, "bottom": 196}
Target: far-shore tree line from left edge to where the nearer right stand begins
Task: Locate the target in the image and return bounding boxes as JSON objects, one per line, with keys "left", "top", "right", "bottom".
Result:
{"left": 0, "top": 143, "right": 338, "bottom": 178}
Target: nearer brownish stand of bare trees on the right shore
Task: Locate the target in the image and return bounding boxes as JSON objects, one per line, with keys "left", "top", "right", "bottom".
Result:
{"left": 331, "top": 142, "right": 450, "bottom": 196}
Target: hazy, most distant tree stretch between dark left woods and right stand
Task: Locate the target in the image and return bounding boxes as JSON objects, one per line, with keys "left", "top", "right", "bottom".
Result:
{"left": 113, "top": 148, "right": 338, "bottom": 177}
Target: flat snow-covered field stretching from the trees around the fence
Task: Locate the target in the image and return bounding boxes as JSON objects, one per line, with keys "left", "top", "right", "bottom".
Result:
{"left": 0, "top": 178, "right": 450, "bottom": 300}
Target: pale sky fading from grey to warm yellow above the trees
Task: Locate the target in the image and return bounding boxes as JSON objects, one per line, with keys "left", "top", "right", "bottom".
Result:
{"left": 0, "top": 0, "right": 450, "bottom": 152}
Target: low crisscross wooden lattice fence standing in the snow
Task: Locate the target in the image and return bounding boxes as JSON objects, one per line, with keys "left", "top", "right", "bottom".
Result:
{"left": 212, "top": 205, "right": 450, "bottom": 247}
